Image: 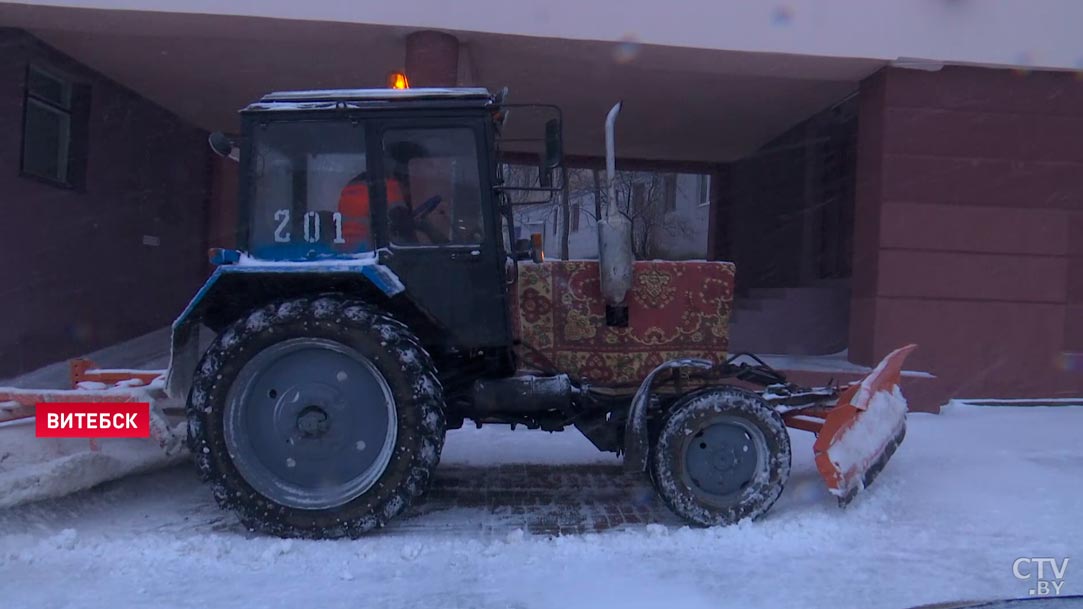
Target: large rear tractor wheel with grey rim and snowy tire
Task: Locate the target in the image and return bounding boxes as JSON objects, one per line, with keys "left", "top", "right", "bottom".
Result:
{"left": 187, "top": 296, "right": 445, "bottom": 539}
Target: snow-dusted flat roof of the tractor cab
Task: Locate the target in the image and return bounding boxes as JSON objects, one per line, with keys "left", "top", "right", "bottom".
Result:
{"left": 243, "top": 88, "right": 494, "bottom": 112}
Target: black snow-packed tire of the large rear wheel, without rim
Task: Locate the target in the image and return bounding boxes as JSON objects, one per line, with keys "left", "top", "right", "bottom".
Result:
{"left": 187, "top": 294, "right": 446, "bottom": 539}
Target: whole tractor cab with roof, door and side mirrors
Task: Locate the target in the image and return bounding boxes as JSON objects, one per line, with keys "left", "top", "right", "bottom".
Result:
{"left": 200, "top": 89, "right": 561, "bottom": 358}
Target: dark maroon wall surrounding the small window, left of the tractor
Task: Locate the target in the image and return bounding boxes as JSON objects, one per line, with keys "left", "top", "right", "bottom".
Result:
{"left": 0, "top": 28, "right": 210, "bottom": 377}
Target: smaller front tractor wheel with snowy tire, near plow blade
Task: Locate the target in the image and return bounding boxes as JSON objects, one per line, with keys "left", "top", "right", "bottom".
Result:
{"left": 650, "top": 386, "right": 790, "bottom": 527}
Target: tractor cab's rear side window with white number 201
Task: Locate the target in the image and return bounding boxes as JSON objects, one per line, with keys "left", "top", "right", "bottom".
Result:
{"left": 248, "top": 120, "right": 371, "bottom": 259}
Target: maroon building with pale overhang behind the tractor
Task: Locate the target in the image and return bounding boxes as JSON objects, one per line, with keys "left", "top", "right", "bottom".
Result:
{"left": 0, "top": 0, "right": 1083, "bottom": 406}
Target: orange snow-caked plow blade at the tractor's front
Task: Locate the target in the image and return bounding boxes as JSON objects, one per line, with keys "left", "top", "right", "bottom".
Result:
{"left": 812, "top": 345, "right": 917, "bottom": 505}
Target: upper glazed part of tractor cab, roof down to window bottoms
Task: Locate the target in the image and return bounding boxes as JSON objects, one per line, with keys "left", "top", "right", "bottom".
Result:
{"left": 240, "top": 89, "right": 499, "bottom": 255}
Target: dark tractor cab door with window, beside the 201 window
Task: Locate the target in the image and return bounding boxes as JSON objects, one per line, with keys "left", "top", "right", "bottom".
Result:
{"left": 369, "top": 119, "right": 511, "bottom": 349}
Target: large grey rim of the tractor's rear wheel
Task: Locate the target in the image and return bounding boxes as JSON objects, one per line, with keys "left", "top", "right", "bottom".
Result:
{"left": 224, "top": 338, "right": 397, "bottom": 509}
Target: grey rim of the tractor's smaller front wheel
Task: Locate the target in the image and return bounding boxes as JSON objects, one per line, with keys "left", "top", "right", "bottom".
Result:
{"left": 682, "top": 415, "right": 768, "bottom": 506}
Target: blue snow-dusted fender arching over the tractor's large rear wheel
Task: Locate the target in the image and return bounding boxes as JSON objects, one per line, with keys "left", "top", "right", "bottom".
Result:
{"left": 166, "top": 251, "right": 405, "bottom": 400}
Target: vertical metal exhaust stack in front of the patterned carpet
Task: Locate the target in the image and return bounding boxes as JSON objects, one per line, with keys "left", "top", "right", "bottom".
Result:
{"left": 598, "top": 102, "right": 634, "bottom": 326}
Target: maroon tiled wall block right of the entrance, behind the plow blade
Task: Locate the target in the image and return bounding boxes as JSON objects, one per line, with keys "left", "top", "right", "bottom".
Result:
{"left": 850, "top": 67, "right": 1083, "bottom": 401}
